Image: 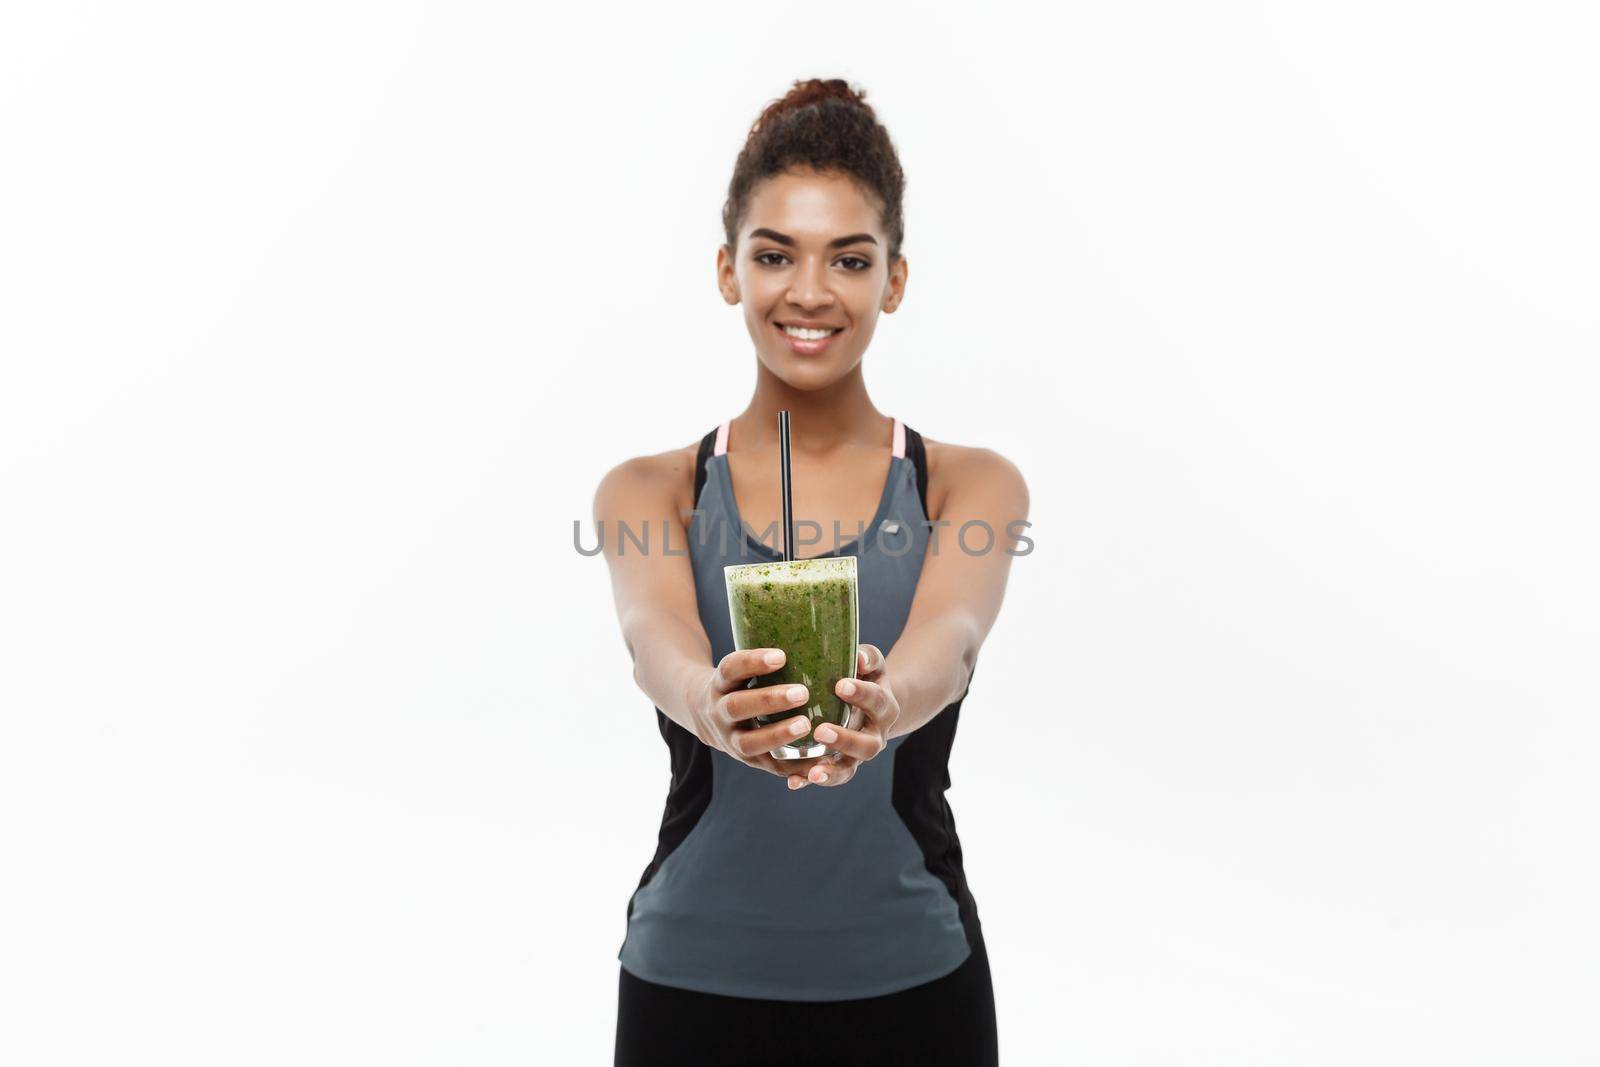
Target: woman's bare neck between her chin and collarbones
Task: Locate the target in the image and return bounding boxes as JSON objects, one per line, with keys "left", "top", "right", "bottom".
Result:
{"left": 731, "top": 363, "right": 890, "bottom": 453}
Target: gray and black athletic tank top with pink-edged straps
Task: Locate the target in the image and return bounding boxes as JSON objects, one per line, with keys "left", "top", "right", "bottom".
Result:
{"left": 618, "top": 419, "right": 981, "bottom": 1001}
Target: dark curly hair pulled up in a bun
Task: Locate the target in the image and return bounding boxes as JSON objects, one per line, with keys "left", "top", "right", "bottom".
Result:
{"left": 722, "top": 78, "right": 906, "bottom": 264}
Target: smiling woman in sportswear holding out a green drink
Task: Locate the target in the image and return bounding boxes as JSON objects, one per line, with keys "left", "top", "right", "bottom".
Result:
{"left": 595, "top": 80, "right": 1027, "bottom": 1067}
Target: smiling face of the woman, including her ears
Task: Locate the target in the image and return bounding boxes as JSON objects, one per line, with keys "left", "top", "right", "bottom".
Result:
{"left": 717, "top": 171, "right": 907, "bottom": 389}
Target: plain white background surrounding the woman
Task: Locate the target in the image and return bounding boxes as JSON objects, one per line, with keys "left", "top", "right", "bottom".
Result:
{"left": 0, "top": 0, "right": 1600, "bottom": 1067}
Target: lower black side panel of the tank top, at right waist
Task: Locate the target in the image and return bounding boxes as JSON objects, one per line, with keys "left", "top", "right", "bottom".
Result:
{"left": 890, "top": 667, "right": 982, "bottom": 949}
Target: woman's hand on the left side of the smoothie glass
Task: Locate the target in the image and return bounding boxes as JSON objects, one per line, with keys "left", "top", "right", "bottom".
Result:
{"left": 694, "top": 648, "right": 827, "bottom": 777}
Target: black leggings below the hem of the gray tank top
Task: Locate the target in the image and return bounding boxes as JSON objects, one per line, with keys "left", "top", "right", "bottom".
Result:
{"left": 614, "top": 934, "right": 1000, "bottom": 1067}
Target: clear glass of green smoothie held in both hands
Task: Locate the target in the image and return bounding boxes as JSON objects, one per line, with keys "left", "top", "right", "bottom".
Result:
{"left": 722, "top": 555, "right": 861, "bottom": 760}
